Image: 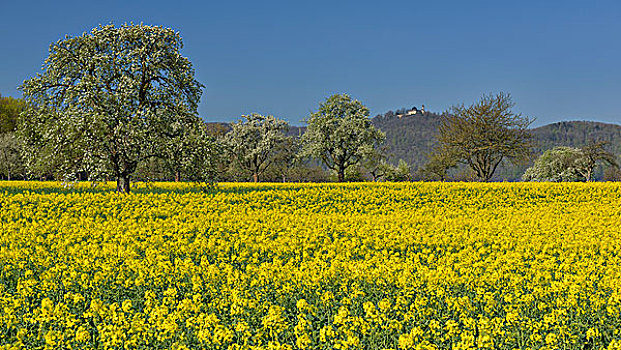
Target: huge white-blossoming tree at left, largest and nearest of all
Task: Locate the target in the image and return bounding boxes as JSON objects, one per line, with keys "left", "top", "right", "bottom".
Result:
{"left": 20, "top": 24, "right": 202, "bottom": 193}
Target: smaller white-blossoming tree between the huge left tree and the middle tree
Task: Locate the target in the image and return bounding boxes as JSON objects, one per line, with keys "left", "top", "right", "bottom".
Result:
{"left": 224, "top": 113, "right": 289, "bottom": 182}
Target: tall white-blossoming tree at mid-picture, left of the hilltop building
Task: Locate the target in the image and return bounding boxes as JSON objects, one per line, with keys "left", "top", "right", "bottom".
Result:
{"left": 302, "top": 94, "right": 385, "bottom": 182}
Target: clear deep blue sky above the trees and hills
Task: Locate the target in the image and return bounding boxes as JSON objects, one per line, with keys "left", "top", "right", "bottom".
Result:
{"left": 0, "top": 0, "right": 621, "bottom": 126}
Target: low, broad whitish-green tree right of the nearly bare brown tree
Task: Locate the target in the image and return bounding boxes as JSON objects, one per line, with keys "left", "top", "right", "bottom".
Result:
{"left": 522, "top": 146, "right": 584, "bottom": 182}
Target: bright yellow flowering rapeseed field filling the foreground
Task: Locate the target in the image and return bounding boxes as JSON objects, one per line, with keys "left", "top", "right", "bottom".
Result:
{"left": 0, "top": 182, "right": 621, "bottom": 350}
